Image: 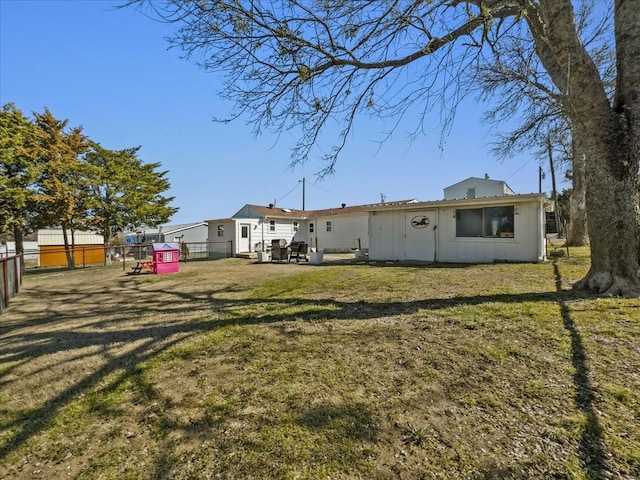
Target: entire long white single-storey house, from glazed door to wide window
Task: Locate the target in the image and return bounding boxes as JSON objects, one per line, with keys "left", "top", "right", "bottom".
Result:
{"left": 207, "top": 177, "right": 546, "bottom": 263}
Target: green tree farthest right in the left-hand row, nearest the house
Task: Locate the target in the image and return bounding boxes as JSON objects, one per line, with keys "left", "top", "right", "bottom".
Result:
{"left": 84, "top": 144, "right": 178, "bottom": 261}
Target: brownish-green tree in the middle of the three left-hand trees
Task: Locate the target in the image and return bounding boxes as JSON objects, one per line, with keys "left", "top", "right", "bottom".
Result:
{"left": 34, "top": 109, "right": 89, "bottom": 268}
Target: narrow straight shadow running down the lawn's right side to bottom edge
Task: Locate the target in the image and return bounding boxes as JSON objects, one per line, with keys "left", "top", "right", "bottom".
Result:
{"left": 553, "top": 260, "right": 608, "bottom": 480}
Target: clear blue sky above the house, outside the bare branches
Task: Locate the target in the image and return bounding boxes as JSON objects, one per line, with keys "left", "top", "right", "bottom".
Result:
{"left": 0, "top": 0, "right": 552, "bottom": 224}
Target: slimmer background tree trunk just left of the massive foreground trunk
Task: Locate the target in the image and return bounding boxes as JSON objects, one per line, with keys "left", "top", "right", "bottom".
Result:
{"left": 567, "top": 137, "right": 589, "bottom": 247}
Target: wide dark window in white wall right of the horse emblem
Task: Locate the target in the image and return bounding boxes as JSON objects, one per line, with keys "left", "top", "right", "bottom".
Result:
{"left": 456, "top": 206, "right": 514, "bottom": 238}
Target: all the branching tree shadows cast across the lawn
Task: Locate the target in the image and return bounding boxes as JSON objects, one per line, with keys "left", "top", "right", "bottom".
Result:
{"left": 0, "top": 264, "right": 606, "bottom": 479}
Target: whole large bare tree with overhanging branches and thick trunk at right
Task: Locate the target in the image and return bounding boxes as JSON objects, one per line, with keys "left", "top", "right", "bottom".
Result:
{"left": 129, "top": 0, "right": 640, "bottom": 296}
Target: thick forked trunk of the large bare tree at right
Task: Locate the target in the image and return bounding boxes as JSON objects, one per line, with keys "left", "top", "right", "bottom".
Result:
{"left": 529, "top": 0, "right": 640, "bottom": 296}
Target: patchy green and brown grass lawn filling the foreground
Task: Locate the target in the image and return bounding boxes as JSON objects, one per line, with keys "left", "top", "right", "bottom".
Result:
{"left": 0, "top": 249, "right": 640, "bottom": 480}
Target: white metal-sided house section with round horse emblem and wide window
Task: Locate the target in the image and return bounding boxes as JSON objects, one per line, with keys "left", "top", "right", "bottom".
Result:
{"left": 367, "top": 177, "right": 546, "bottom": 263}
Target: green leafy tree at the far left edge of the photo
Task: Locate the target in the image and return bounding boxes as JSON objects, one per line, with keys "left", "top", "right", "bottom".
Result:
{"left": 0, "top": 103, "right": 37, "bottom": 253}
